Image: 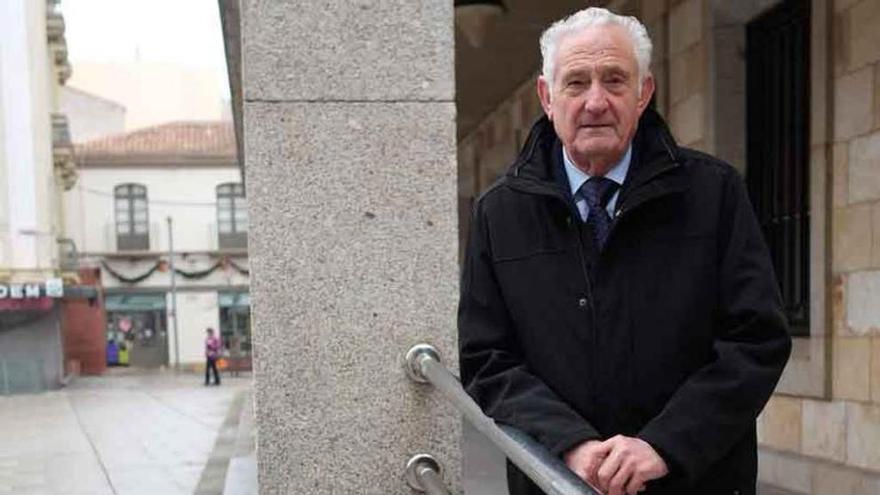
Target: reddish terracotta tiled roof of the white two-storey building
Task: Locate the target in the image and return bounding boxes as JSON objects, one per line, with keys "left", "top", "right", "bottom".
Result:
{"left": 76, "top": 121, "right": 236, "bottom": 159}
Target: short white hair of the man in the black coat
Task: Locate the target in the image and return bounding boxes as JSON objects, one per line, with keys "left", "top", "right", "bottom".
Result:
{"left": 540, "top": 7, "right": 653, "bottom": 91}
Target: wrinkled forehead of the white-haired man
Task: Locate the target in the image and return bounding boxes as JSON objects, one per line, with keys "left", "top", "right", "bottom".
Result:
{"left": 555, "top": 24, "right": 638, "bottom": 72}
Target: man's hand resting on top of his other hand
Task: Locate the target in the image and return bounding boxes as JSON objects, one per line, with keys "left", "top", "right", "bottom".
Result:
{"left": 596, "top": 435, "right": 669, "bottom": 495}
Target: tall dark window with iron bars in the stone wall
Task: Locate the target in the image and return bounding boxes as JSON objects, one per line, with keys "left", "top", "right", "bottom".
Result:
{"left": 746, "top": 0, "right": 810, "bottom": 335}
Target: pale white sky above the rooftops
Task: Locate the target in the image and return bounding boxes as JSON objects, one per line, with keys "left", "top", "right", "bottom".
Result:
{"left": 61, "top": 0, "right": 229, "bottom": 98}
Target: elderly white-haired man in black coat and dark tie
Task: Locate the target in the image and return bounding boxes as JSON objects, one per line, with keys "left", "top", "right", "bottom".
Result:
{"left": 459, "top": 8, "right": 791, "bottom": 495}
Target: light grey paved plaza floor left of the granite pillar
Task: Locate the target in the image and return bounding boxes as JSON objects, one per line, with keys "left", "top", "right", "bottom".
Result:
{"left": 0, "top": 369, "right": 256, "bottom": 495}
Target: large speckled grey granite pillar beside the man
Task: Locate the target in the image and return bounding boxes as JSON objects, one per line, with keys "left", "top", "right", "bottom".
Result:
{"left": 241, "top": 0, "right": 461, "bottom": 494}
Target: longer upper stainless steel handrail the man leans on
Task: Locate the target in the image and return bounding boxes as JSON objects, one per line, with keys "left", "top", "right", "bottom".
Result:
{"left": 405, "top": 344, "right": 599, "bottom": 495}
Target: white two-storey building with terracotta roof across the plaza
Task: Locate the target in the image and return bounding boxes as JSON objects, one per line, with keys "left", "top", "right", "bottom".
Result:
{"left": 64, "top": 121, "right": 250, "bottom": 368}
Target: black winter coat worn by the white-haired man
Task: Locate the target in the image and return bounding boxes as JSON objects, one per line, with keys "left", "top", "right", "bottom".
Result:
{"left": 459, "top": 110, "right": 791, "bottom": 494}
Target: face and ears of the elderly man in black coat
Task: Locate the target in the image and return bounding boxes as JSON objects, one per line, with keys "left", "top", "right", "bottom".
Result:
{"left": 538, "top": 25, "right": 654, "bottom": 175}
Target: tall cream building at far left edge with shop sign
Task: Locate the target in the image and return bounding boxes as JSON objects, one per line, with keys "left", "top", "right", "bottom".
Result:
{"left": 0, "top": 0, "right": 76, "bottom": 394}
